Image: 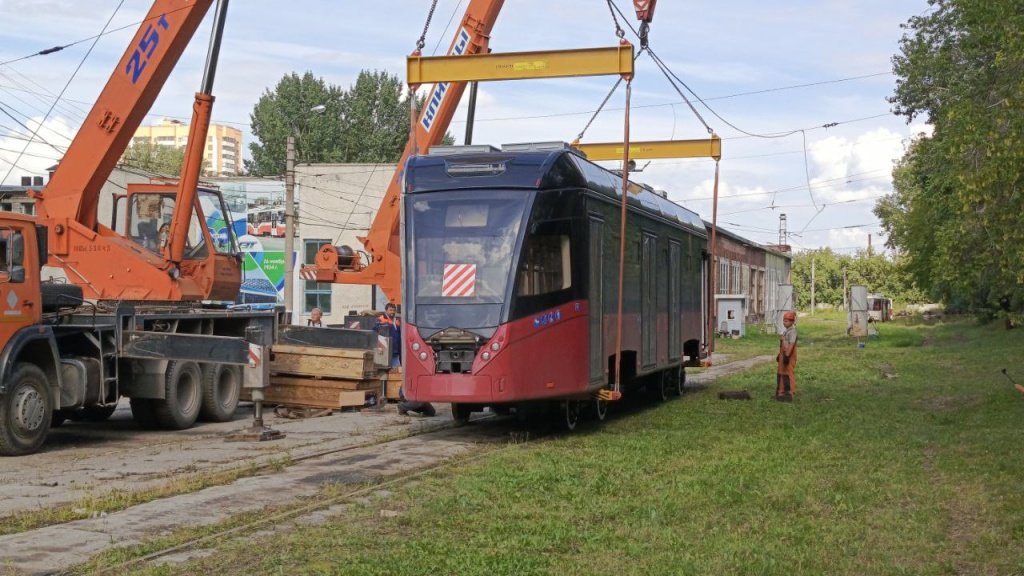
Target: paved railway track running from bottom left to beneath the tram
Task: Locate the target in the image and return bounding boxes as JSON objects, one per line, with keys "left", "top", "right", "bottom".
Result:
{"left": 0, "top": 357, "right": 767, "bottom": 574}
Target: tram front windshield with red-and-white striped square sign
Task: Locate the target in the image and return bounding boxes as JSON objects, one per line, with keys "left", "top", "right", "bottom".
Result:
{"left": 406, "top": 190, "right": 532, "bottom": 333}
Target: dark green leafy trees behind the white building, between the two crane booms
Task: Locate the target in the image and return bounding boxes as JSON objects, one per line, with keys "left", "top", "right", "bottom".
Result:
{"left": 246, "top": 70, "right": 454, "bottom": 176}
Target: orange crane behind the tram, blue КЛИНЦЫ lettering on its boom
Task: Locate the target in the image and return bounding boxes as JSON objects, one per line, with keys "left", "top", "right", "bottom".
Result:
{"left": 300, "top": 0, "right": 657, "bottom": 302}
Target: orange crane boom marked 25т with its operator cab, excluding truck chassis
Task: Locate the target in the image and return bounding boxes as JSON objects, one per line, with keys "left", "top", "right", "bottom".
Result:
{"left": 35, "top": 0, "right": 242, "bottom": 301}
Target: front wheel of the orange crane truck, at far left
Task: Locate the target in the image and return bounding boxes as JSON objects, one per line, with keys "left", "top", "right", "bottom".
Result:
{"left": 0, "top": 363, "right": 53, "bottom": 456}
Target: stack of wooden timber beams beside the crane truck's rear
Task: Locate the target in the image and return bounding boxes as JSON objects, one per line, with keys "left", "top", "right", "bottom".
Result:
{"left": 242, "top": 326, "right": 384, "bottom": 409}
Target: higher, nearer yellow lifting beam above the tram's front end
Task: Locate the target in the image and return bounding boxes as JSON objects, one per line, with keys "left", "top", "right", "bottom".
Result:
{"left": 406, "top": 42, "right": 633, "bottom": 86}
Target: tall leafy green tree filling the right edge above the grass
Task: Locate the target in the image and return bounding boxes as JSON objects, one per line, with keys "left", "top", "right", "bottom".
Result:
{"left": 874, "top": 0, "right": 1024, "bottom": 320}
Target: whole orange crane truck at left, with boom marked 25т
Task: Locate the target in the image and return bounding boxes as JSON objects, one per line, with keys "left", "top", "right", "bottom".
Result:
{"left": 0, "top": 0, "right": 284, "bottom": 455}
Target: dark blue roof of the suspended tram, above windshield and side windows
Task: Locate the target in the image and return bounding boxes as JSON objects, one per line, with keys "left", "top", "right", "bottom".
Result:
{"left": 406, "top": 150, "right": 707, "bottom": 235}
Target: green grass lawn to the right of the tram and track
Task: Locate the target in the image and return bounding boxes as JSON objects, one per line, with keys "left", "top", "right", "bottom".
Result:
{"left": 94, "top": 316, "right": 1024, "bottom": 576}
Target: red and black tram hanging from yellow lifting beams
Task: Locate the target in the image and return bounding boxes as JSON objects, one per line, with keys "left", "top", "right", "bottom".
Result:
{"left": 402, "top": 145, "right": 708, "bottom": 427}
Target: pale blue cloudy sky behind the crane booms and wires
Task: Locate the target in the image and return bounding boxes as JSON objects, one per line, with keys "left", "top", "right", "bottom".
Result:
{"left": 0, "top": 0, "right": 928, "bottom": 253}
